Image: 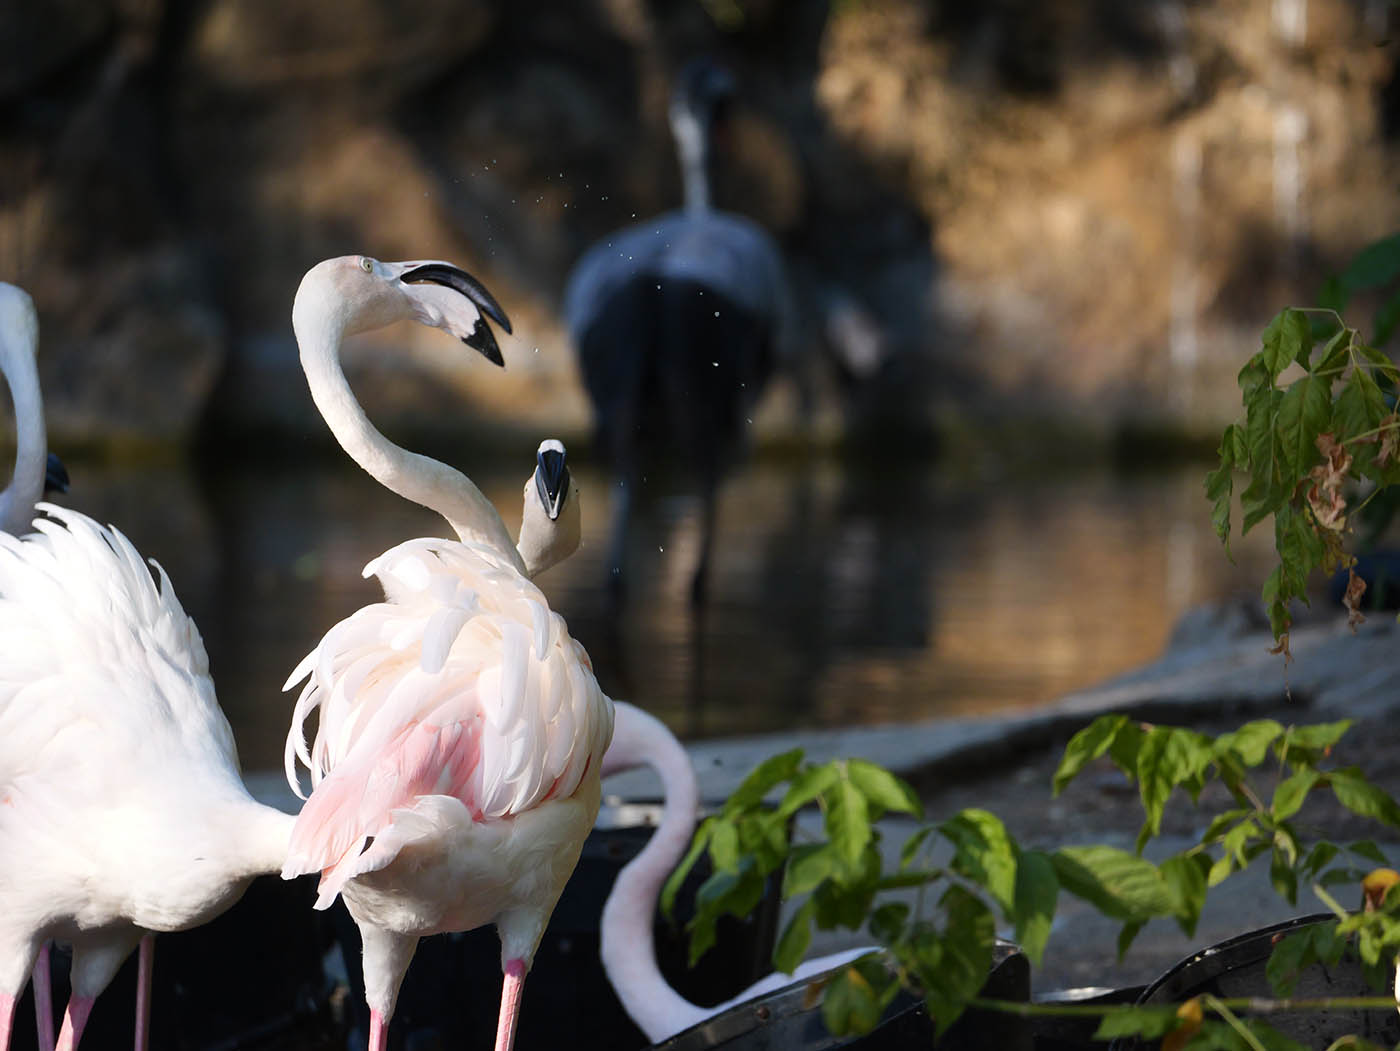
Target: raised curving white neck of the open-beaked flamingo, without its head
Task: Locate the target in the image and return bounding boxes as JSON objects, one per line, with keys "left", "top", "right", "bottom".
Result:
{"left": 291, "top": 287, "right": 525, "bottom": 572}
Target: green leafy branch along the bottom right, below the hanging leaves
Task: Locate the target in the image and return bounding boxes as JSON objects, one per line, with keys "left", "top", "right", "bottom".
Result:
{"left": 662, "top": 715, "right": 1400, "bottom": 1048}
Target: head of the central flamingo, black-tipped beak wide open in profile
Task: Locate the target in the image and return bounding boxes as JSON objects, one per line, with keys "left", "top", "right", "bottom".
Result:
{"left": 291, "top": 256, "right": 511, "bottom": 365}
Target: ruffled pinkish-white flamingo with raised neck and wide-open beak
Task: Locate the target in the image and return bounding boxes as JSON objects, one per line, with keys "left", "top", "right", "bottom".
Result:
{"left": 283, "top": 256, "right": 612, "bottom": 1051}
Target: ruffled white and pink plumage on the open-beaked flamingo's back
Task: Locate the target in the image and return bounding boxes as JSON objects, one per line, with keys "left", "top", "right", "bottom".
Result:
{"left": 283, "top": 539, "right": 612, "bottom": 907}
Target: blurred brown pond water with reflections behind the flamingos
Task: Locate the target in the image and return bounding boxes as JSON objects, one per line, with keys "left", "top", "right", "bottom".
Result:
{"left": 57, "top": 449, "right": 1267, "bottom": 768}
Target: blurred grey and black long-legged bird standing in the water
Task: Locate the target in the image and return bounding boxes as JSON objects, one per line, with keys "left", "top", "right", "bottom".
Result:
{"left": 564, "top": 60, "right": 798, "bottom": 603}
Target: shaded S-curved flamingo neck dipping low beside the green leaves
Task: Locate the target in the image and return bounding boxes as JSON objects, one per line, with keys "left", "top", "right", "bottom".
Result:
{"left": 599, "top": 701, "right": 876, "bottom": 1044}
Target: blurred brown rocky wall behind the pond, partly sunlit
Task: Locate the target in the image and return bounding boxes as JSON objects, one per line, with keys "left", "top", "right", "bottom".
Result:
{"left": 0, "top": 0, "right": 1400, "bottom": 453}
